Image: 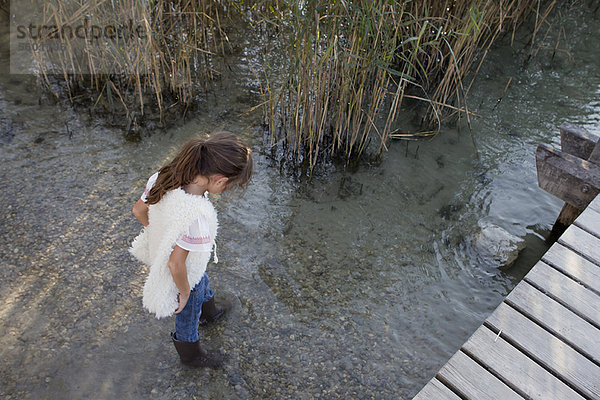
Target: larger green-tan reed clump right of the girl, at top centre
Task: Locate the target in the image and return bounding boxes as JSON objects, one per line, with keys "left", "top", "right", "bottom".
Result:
{"left": 265, "top": 0, "right": 556, "bottom": 171}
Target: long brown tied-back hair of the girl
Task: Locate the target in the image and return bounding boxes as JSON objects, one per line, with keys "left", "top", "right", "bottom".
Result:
{"left": 146, "top": 131, "right": 253, "bottom": 204}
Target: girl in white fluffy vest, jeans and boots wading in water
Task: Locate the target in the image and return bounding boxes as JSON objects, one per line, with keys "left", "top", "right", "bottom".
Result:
{"left": 129, "top": 132, "right": 252, "bottom": 367}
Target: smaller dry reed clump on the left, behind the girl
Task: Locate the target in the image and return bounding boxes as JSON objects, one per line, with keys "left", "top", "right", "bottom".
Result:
{"left": 29, "top": 0, "right": 228, "bottom": 136}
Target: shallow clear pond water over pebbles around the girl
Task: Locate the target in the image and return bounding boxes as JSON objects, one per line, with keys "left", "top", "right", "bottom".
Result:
{"left": 0, "top": 5, "right": 600, "bottom": 399}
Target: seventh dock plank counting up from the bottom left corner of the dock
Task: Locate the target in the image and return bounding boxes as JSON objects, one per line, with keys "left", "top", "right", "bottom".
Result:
{"left": 542, "top": 243, "right": 600, "bottom": 293}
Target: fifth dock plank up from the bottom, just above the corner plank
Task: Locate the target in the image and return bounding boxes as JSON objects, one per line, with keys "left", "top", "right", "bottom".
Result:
{"left": 505, "top": 282, "right": 600, "bottom": 363}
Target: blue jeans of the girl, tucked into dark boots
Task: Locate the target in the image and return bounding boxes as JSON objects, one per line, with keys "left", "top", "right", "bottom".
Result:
{"left": 175, "top": 273, "right": 215, "bottom": 342}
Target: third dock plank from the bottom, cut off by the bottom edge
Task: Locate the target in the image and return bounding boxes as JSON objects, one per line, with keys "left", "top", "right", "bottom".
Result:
{"left": 463, "top": 326, "right": 583, "bottom": 400}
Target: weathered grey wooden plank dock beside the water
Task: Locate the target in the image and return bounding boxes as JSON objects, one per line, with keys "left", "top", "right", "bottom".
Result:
{"left": 415, "top": 196, "right": 600, "bottom": 400}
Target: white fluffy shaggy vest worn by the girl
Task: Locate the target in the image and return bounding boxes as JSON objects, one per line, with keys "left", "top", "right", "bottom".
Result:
{"left": 129, "top": 189, "right": 218, "bottom": 318}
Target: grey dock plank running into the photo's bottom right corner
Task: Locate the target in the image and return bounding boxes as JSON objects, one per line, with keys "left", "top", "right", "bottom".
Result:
{"left": 487, "top": 303, "right": 600, "bottom": 400}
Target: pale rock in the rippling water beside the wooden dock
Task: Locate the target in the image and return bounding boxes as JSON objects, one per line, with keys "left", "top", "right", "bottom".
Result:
{"left": 473, "top": 221, "right": 525, "bottom": 268}
